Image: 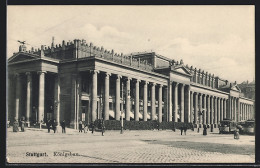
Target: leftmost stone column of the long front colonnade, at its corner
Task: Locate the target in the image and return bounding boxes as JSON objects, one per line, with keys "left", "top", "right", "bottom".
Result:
{"left": 91, "top": 70, "right": 98, "bottom": 122}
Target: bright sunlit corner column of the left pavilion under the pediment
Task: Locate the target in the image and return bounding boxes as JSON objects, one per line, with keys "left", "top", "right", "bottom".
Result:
{"left": 38, "top": 71, "right": 46, "bottom": 122}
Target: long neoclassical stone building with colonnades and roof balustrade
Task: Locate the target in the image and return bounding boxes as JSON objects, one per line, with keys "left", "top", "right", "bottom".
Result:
{"left": 7, "top": 40, "right": 255, "bottom": 128}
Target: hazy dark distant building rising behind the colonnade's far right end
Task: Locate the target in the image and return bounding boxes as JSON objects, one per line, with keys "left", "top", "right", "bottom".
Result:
{"left": 238, "top": 80, "right": 255, "bottom": 100}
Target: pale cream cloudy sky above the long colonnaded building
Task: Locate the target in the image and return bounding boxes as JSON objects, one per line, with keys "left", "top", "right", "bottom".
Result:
{"left": 7, "top": 5, "right": 255, "bottom": 83}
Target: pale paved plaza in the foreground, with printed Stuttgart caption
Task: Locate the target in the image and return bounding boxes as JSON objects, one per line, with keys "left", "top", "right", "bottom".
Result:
{"left": 7, "top": 128, "right": 255, "bottom": 163}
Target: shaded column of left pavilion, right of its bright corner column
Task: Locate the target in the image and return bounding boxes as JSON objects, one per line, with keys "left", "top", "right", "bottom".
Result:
{"left": 54, "top": 74, "right": 60, "bottom": 124}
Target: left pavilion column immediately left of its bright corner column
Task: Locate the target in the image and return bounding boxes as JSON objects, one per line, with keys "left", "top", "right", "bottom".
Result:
{"left": 26, "top": 72, "right": 32, "bottom": 127}
